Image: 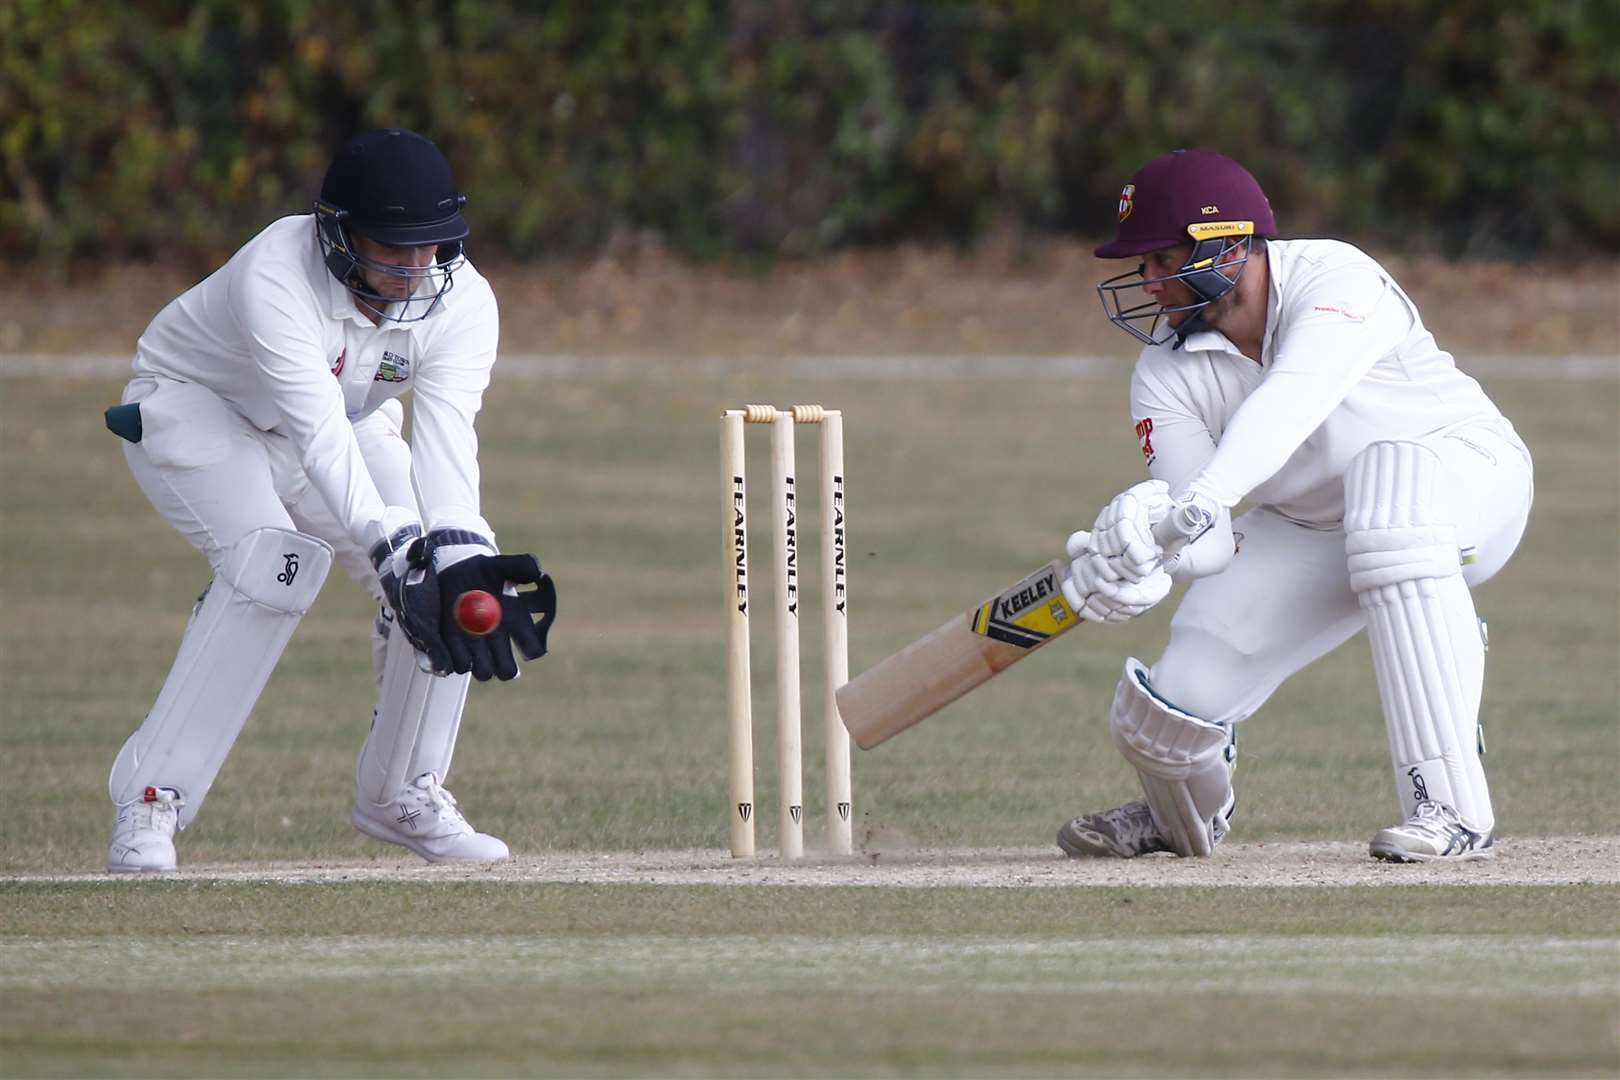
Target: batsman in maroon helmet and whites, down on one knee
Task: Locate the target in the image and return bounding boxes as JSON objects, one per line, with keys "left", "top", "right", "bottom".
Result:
{"left": 1058, "top": 151, "right": 1533, "bottom": 863}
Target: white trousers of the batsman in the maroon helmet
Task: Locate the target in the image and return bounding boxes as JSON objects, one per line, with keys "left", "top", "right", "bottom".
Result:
{"left": 1152, "top": 419, "right": 1533, "bottom": 724}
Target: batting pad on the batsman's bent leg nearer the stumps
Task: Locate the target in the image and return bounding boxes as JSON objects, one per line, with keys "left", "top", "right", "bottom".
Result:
{"left": 1108, "top": 657, "right": 1233, "bottom": 855}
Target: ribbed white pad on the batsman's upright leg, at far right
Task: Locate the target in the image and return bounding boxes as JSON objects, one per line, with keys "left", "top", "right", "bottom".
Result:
{"left": 1345, "top": 442, "right": 1495, "bottom": 832}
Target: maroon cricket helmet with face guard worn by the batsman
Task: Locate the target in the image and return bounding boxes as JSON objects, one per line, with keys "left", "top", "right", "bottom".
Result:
{"left": 1094, "top": 151, "right": 1277, "bottom": 345}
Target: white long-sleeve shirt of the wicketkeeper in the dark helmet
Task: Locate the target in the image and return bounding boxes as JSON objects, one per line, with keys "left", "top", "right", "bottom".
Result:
{"left": 134, "top": 214, "right": 499, "bottom": 546}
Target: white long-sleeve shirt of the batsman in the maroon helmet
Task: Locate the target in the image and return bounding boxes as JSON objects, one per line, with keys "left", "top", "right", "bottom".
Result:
{"left": 1131, "top": 240, "right": 1500, "bottom": 528}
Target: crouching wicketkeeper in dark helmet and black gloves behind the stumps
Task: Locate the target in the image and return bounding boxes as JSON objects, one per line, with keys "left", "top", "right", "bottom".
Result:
{"left": 107, "top": 130, "right": 556, "bottom": 871}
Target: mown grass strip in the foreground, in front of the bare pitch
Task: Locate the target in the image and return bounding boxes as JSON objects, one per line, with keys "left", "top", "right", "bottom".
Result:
{"left": 0, "top": 882, "right": 1617, "bottom": 1077}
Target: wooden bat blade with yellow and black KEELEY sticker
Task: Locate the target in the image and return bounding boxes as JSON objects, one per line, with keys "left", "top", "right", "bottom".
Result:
{"left": 838, "top": 560, "right": 1084, "bottom": 750}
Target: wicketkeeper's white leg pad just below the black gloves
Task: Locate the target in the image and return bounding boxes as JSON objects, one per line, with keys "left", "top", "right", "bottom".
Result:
{"left": 355, "top": 614, "right": 471, "bottom": 805}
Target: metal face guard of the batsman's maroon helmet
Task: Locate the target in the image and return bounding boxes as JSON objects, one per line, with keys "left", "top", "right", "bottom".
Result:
{"left": 1097, "top": 231, "right": 1254, "bottom": 345}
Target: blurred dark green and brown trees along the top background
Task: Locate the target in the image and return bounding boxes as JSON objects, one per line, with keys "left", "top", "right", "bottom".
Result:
{"left": 0, "top": 0, "right": 1620, "bottom": 269}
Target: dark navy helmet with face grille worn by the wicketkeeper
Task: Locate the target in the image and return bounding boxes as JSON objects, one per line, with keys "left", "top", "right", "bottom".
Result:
{"left": 314, "top": 128, "right": 468, "bottom": 322}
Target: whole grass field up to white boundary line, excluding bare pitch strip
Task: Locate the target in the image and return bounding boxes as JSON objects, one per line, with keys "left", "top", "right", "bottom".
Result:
{"left": 0, "top": 352, "right": 1620, "bottom": 1075}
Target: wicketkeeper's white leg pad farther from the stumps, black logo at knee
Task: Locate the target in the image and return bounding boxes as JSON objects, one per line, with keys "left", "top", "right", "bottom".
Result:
{"left": 107, "top": 528, "right": 332, "bottom": 829}
